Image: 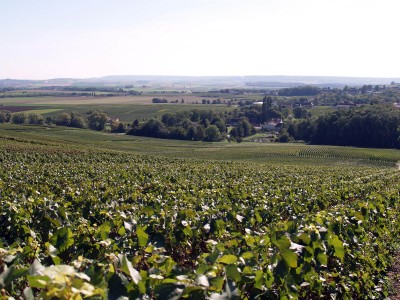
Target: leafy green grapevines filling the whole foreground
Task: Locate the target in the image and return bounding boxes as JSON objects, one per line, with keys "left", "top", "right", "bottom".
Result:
{"left": 0, "top": 135, "right": 400, "bottom": 299}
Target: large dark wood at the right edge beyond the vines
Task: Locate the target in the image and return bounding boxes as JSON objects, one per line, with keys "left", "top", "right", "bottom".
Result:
{"left": 287, "top": 105, "right": 400, "bottom": 148}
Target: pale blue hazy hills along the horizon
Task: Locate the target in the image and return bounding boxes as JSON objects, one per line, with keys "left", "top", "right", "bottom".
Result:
{"left": 0, "top": 75, "right": 400, "bottom": 90}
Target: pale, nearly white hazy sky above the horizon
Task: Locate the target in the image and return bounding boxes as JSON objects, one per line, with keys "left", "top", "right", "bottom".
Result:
{"left": 0, "top": 0, "right": 400, "bottom": 79}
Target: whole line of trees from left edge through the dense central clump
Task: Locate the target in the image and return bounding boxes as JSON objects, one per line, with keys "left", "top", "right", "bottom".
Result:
{"left": 0, "top": 109, "right": 255, "bottom": 142}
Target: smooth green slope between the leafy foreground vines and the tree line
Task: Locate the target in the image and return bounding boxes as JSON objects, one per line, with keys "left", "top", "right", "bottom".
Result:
{"left": 0, "top": 124, "right": 400, "bottom": 167}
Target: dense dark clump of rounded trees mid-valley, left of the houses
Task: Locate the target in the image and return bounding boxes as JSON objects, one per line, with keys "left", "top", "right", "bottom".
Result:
{"left": 127, "top": 109, "right": 255, "bottom": 142}
